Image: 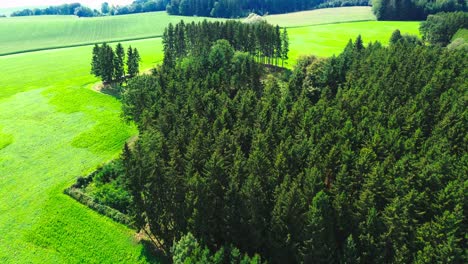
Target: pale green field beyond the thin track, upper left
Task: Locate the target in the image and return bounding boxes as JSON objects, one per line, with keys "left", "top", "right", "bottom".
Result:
{"left": 0, "top": 12, "right": 218, "bottom": 55}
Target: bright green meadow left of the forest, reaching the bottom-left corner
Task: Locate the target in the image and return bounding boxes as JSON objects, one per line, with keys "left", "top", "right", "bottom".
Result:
{"left": 0, "top": 39, "right": 162, "bottom": 263}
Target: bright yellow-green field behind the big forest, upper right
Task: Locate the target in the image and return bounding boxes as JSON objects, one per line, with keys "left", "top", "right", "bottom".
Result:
{"left": 288, "top": 21, "right": 419, "bottom": 65}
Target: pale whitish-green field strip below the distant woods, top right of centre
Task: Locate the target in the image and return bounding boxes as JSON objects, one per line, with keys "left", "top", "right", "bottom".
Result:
{"left": 266, "top": 6, "right": 376, "bottom": 27}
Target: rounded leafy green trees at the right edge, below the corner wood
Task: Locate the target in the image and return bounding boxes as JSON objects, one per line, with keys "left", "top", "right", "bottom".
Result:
{"left": 420, "top": 12, "right": 468, "bottom": 46}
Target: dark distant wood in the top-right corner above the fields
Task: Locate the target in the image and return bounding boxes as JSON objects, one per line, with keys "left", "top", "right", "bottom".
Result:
{"left": 372, "top": 0, "right": 468, "bottom": 20}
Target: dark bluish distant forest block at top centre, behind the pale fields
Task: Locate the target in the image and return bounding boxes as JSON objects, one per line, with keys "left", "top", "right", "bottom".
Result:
{"left": 167, "top": 0, "right": 369, "bottom": 18}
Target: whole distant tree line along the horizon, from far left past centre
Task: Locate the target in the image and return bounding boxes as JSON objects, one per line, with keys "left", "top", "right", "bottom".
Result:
{"left": 11, "top": 0, "right": 369, "bottom": 18}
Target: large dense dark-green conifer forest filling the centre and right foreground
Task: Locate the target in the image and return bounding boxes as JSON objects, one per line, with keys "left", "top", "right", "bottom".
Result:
{"left": 122, "top": 25, "right": 468, "bottom": 263}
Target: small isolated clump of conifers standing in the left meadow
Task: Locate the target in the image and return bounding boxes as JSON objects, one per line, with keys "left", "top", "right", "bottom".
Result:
{"left": 91, "top": 43, "right": 141, "bottom": 84}
